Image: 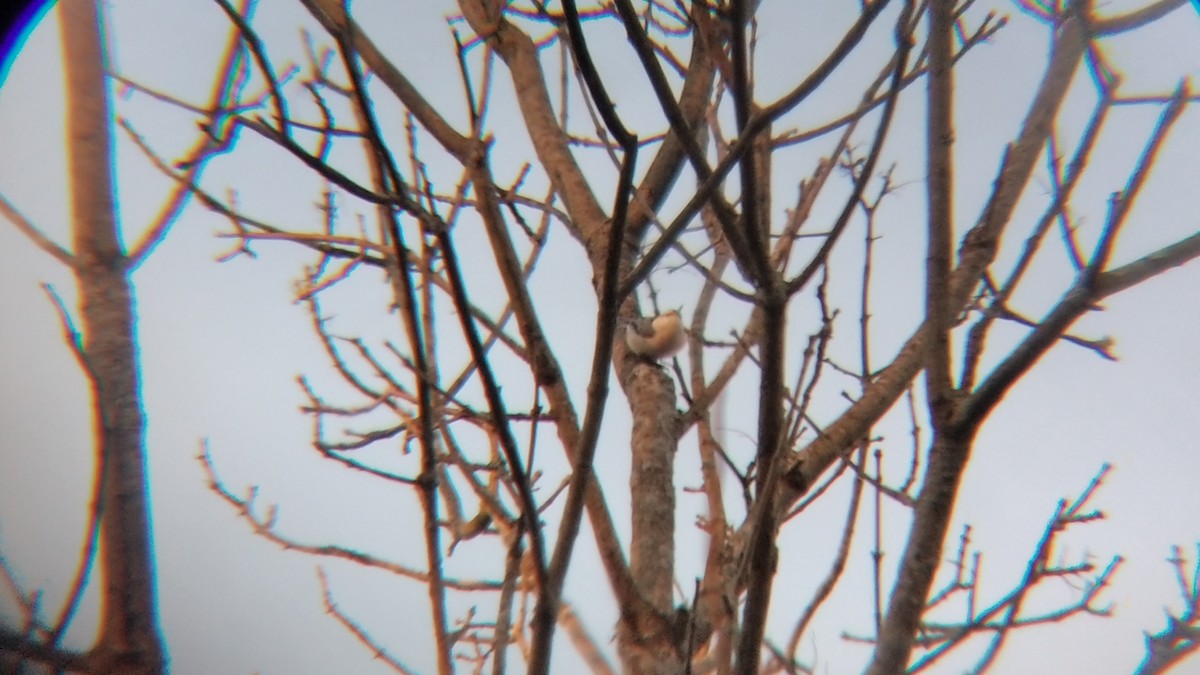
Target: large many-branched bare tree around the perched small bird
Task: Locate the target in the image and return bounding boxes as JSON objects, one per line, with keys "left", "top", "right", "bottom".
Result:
{"left": 2, "top": 0, "right": 1200, "bottom": 674}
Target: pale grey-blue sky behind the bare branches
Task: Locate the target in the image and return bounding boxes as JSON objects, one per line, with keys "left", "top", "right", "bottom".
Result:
{"left": 0, "top": 0, "right": 1200, "bottom": 674}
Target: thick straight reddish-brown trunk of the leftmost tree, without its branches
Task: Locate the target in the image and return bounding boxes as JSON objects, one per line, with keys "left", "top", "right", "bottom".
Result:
{"left": 60, "top": 0, "right": 164, "bottom": 674}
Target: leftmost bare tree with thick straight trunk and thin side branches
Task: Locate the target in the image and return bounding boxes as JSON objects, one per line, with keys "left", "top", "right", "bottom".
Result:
{"left": 0, "top": 0, "right": 249, "bottom": 675}
